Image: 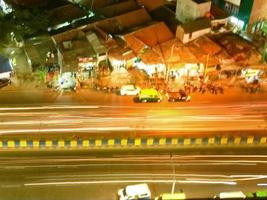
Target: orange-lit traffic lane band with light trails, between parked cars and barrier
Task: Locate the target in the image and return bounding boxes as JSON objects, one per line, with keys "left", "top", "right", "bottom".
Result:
{"left": 0, "top": 102, "right": 267, "bottom": 135}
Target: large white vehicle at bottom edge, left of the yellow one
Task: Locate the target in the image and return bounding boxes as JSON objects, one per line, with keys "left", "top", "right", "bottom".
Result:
{"left": 118, "top": 183, "right": 151, "bottom": 200}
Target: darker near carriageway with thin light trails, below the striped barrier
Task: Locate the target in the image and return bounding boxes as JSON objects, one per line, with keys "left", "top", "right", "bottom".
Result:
{"left": 0, "top": 150, "right": 267, "bottom": 200}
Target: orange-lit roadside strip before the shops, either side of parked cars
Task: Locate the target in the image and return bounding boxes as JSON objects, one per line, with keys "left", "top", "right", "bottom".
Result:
{"left": 0, "top": 81, "right": 267, "bottom": 106}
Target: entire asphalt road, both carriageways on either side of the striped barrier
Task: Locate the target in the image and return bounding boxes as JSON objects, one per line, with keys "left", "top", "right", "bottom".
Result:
{"left": 0, "top": 86, "right": 267, "bottom": 200}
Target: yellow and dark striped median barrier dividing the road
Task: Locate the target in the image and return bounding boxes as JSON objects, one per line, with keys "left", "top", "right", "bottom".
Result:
{"left": 0, "top": 136, "right": 267, "bottom": 150}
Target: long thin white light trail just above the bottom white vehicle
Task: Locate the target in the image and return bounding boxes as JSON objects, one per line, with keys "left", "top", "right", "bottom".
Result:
{"left": 24, "top": 179, "right": 236, "bottom": 186}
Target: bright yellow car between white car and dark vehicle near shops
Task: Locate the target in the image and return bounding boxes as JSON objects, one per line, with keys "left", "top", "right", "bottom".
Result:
{"left": 138, "top": 89, "right": 162, "bottom": 103}
